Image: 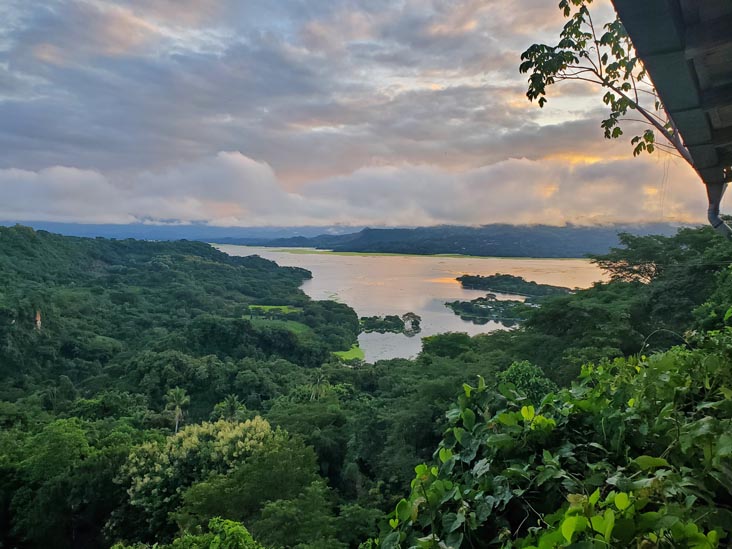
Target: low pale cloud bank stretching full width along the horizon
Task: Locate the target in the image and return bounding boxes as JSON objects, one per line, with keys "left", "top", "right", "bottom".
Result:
{"left": 0, "top": 152, "right": 704, "bottom": 226}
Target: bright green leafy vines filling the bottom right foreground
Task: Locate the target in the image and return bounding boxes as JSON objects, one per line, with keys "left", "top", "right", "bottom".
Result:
{"left": 381, "top": 328, "right": 732, "bottom": 549}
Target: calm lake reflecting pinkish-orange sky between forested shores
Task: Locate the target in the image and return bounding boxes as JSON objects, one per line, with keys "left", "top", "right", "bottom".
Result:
{"left": 215, "top": 244, "right": 604, "bottom": 362}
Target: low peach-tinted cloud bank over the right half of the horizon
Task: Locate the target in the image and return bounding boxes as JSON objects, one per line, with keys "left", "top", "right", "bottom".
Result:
{"left": 304, "top": 153, "right": 704, "bottom": 225}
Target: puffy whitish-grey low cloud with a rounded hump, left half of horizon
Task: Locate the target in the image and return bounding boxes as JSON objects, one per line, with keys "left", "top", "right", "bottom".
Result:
{"left": 0, "top": 152, "right": 314, "bottom": 225}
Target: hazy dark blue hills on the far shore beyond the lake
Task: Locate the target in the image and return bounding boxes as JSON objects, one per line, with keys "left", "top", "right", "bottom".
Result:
{"left": 229, "top": 224, "right": 676, "bottom": 257}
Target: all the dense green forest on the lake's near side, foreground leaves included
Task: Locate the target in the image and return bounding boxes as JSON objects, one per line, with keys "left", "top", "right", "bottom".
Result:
{"left": 0, "top": 227, "right": 732, "bottom": 549}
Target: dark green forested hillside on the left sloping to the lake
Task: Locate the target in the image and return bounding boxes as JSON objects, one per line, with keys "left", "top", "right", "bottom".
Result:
{"left": 0, "top": 226, "right": 358, "bottom": 388}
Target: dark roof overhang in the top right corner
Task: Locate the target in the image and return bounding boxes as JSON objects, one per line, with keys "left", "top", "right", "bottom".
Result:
{"left": 613, "top": 0, "right": 732, "bottom": 185}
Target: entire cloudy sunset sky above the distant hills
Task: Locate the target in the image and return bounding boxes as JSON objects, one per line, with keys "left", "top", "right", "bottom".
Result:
{"left": 0, "top": 0, "right": 706, "bottom": 226}
